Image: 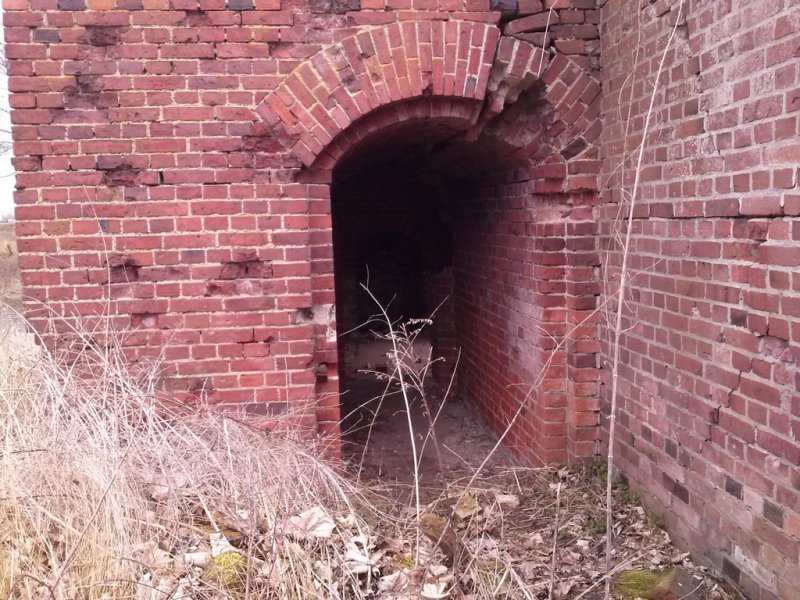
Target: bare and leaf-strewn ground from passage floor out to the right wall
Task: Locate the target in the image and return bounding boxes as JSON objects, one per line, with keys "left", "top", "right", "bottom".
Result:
{"left": 334, "top": 332, "right": 737, "bottom": 600}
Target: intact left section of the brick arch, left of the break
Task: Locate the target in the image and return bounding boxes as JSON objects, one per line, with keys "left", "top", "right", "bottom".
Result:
{"left": 258, "top": 20, "right": 500, "bottom": 167}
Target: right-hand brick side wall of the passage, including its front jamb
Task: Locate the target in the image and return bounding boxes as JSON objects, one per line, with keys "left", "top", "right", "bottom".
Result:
{"left": 454, "top": 180, "right": 598, "bottom": 463}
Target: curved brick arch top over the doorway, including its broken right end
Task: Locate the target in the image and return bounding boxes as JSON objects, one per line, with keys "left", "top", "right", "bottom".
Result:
{"left": 258, "top": 20, "right": 599, "bottom": 167}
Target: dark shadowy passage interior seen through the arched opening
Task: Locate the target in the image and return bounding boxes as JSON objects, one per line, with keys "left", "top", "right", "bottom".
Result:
{"left": 331, "top": 110, "right": 560, "bottom": 478}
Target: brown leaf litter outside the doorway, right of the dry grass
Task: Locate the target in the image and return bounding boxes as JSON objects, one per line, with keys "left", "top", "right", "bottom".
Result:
{"left": 354, "top": 467, "right": 738, "bottom": 600}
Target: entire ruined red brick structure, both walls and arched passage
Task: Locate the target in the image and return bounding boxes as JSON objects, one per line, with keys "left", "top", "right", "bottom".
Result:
{"left": 4, "top": 0, "right": 800, "bottom": 600}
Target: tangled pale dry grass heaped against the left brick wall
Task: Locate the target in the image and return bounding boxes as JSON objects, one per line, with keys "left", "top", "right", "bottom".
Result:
{"left": 0, "top": 320, "right": 380, "bottom": 600}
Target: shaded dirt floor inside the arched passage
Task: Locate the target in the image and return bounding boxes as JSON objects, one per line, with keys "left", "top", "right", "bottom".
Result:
{"left": 342, "top": 333, "right": 510, "bottom": 483}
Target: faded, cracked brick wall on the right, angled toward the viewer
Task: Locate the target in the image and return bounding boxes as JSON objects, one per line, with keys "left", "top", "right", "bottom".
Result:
{"left": 598, "top": 0, "right": 800, "bottom": 599}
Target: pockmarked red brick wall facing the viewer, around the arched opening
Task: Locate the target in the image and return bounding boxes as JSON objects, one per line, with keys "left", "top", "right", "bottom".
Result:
{"left": 4, "top": 0, "right": 599, "bottom": 459}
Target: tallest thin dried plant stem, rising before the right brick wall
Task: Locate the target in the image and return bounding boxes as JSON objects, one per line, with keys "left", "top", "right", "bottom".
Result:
{"left": 604, "top": 0, "right": 683, "bottom": 600}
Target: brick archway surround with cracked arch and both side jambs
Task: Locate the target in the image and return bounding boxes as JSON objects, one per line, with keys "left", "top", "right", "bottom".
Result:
{"left": 268, "top": 20, "right": 600, "bottom": 462}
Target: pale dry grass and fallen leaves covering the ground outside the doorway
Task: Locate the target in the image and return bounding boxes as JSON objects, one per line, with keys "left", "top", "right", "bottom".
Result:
{"left": 0, "top": 223, "right": 724, "bottom": 600}
